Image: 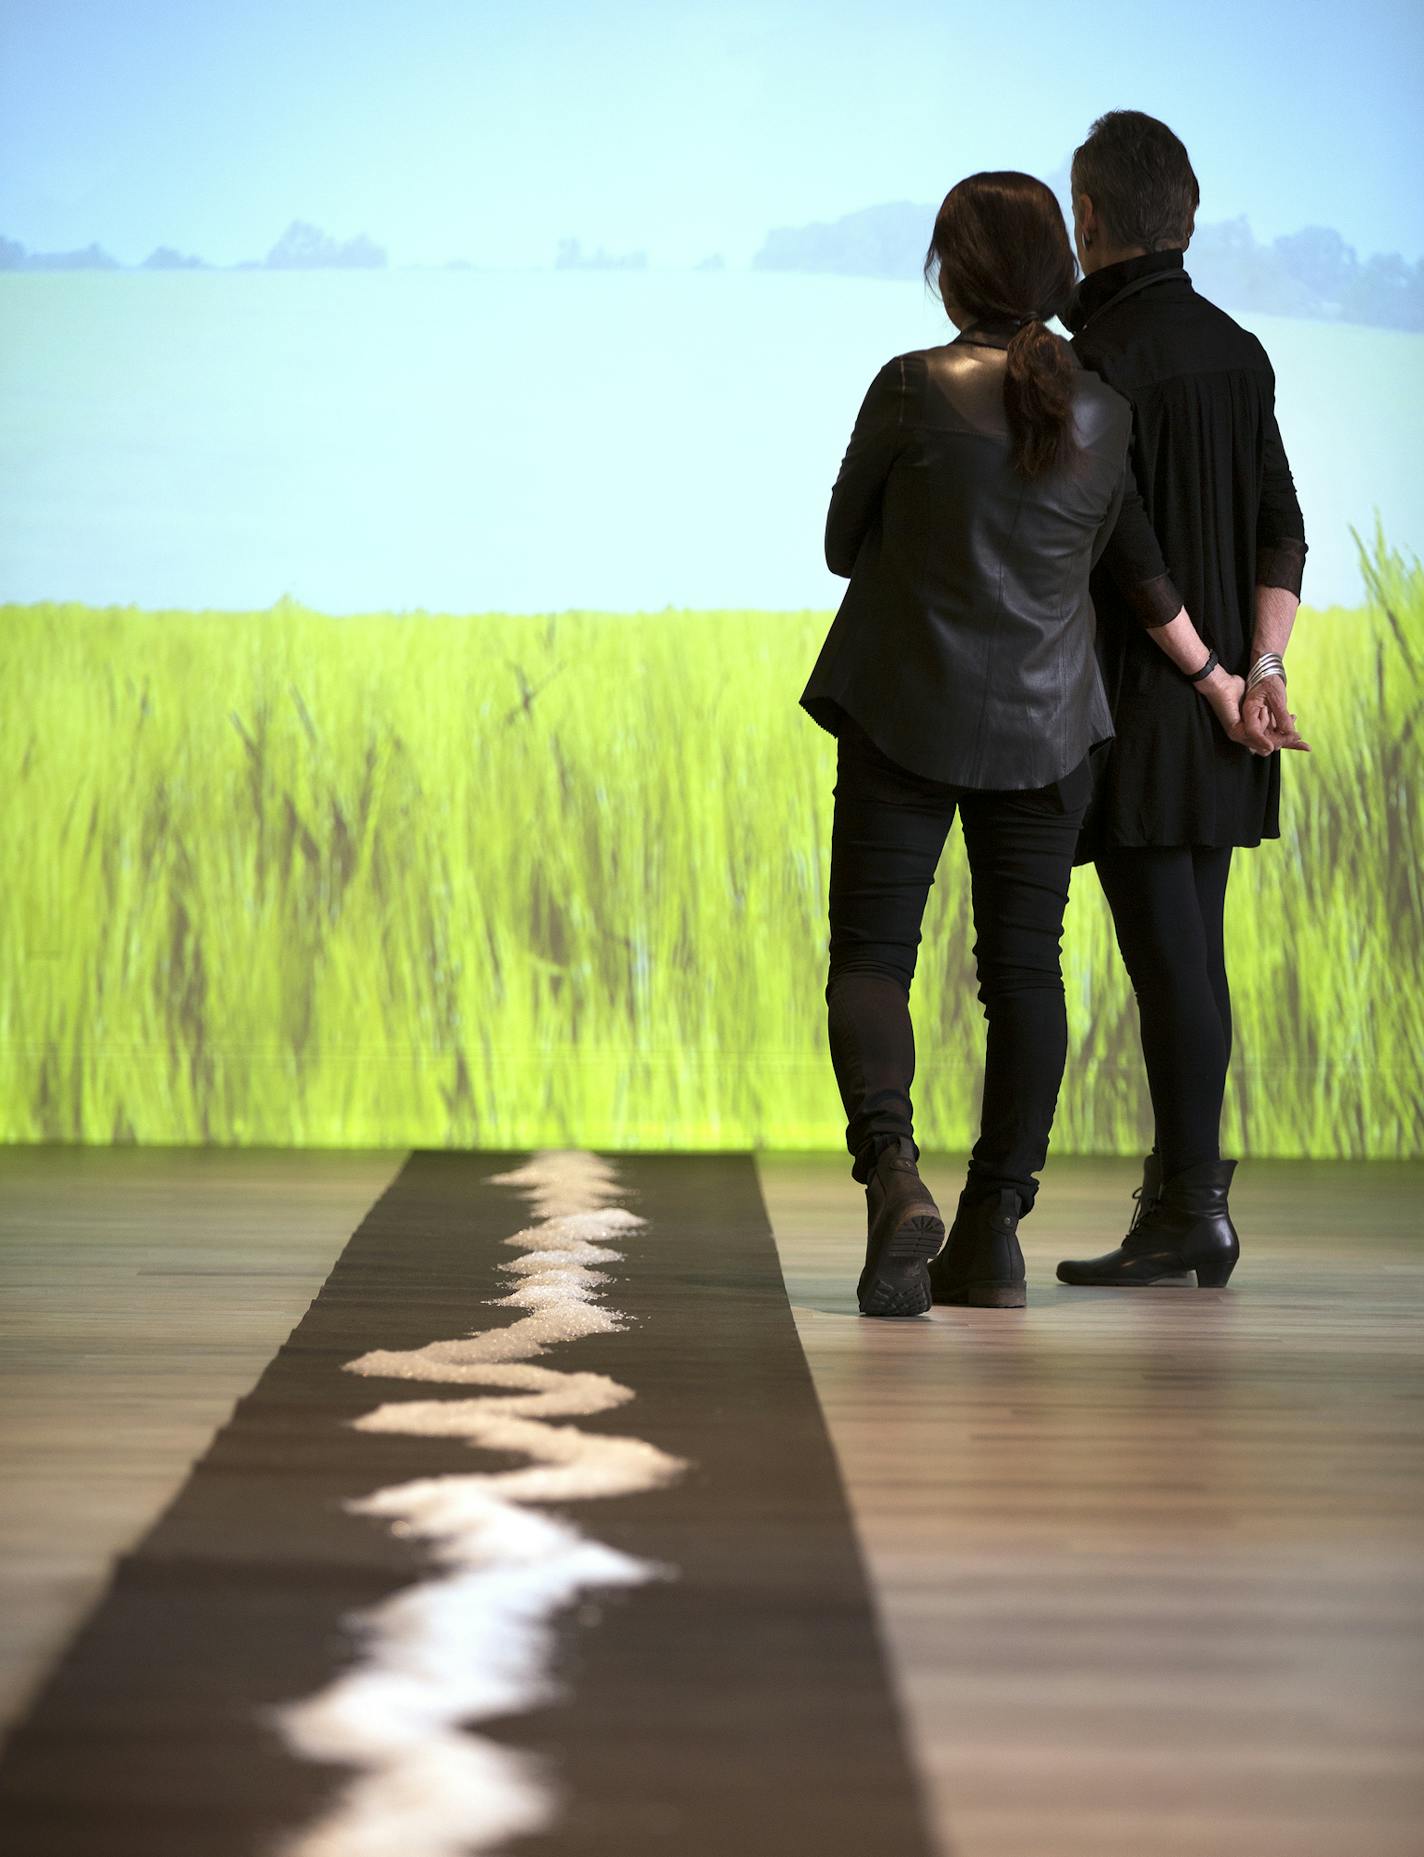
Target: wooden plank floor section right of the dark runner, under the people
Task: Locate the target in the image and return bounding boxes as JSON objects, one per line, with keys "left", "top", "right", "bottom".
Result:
{"left": 761, "top": 1157, "right": 1424, "bottom": 1857}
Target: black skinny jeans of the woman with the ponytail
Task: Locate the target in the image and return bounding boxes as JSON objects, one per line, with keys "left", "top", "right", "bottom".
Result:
{"left": 826, "top": 721, "right": 1090, "bottom": 1211}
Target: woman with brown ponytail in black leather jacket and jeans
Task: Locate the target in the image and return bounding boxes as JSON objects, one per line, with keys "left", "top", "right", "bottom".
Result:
{"left": 802, "top": 173, "right": 1180, "bottom": 1317}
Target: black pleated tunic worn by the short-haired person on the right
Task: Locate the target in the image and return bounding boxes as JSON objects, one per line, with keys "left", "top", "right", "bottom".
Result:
{"left": 1064, "top": 251, "right": 1305, "bottom": 862}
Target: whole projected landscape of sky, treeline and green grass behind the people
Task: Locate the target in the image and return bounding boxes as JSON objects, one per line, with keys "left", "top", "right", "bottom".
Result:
{"left": 0, "top": 6, "right": 1424, "bottom": 1155}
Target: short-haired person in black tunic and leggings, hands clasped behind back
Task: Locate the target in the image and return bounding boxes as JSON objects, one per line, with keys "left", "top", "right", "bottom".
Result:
{"left": 1058, "top": 111, "right": 1305, "bottom": 1287}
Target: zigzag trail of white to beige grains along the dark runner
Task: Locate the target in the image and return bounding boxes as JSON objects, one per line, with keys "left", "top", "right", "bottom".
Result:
{"left": 273, "top": 1153, "right": 685, "bottom": 1857}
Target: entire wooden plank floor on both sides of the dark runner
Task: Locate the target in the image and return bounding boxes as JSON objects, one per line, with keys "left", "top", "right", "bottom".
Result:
{"left": 0, "top": 1149, "right": 1424, "bottom": 1857}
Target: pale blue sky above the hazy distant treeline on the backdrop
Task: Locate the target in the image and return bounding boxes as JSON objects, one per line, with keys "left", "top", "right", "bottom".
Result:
{"left": 0, "top": 0, "right": 1424, "bottom": 266}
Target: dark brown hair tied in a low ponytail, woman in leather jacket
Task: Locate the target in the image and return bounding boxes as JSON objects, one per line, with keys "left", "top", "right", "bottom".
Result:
{"left": 925, "top": 169, "right": 1077, "bottom": 477}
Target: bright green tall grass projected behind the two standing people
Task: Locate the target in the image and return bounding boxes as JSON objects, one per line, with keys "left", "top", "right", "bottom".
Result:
{"left": 0, "top": 542, "right": 1424, "bottom": 1155}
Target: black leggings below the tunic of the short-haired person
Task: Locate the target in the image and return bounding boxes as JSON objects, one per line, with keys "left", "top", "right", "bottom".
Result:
{"left": 1097, "top": 845, "right": 1231, "bottom": 1175}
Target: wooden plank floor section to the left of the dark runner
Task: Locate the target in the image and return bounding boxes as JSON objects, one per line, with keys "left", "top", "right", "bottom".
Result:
{"left": 0, "top": 1148, "right": 405, "bottom": 1731}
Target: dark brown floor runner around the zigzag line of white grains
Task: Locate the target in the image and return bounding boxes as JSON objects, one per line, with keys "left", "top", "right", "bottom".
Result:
{"left": 0, "top": 1153, "right": 932, "bottom": 1857}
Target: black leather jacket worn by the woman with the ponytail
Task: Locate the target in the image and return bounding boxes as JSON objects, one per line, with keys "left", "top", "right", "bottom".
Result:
{"left": 800, "top": 325, "right": 1133, "bottom": 789}
